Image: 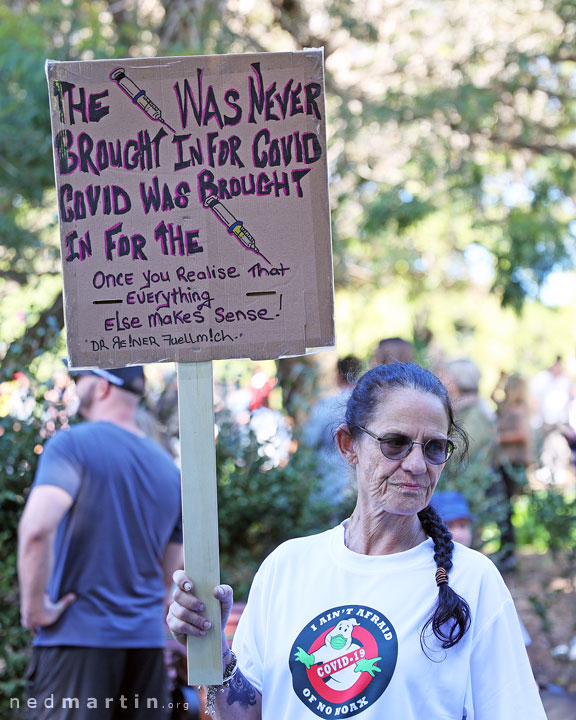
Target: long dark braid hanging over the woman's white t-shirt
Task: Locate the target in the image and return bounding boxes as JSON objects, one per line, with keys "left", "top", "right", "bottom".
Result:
{"left": 418, "top": 505, "right": 470, "bottom": 649}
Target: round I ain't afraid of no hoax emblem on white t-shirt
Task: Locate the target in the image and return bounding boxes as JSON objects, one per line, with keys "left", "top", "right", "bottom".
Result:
{"left": 290, "top": 605, "right": 398, "bottom": 717}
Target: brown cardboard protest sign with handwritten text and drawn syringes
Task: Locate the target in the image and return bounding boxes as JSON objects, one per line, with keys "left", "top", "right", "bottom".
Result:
{"left": 46, "top": 50, "right": 334, "bottom": 368}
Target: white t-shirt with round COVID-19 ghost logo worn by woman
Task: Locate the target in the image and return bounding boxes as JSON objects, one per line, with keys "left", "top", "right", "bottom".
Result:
{"left": 234, "top": 525, "right": 546, "bottom": 720}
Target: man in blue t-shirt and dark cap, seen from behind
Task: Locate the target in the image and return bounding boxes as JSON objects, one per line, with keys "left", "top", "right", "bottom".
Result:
{"left": 18, "top": 366, "right": 182, "bottom": 720}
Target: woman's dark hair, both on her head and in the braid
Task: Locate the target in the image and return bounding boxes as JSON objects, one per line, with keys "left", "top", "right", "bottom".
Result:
{"left": 346, "top": 362, "right": 470, "bottom": 650}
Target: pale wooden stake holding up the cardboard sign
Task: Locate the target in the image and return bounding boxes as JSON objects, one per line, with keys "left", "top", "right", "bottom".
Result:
{"left": 177, "top": 361, "right": 222, "bottom": 685}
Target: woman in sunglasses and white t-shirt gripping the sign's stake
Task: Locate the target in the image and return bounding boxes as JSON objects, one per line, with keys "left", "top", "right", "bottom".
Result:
{"left": 168, "top": 363, "right": 545, "bottom": 720}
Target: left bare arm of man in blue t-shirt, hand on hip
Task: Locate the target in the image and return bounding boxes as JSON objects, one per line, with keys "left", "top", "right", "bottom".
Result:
{"left": 18, "top": 485, "right": 76, "bottom": 632}
